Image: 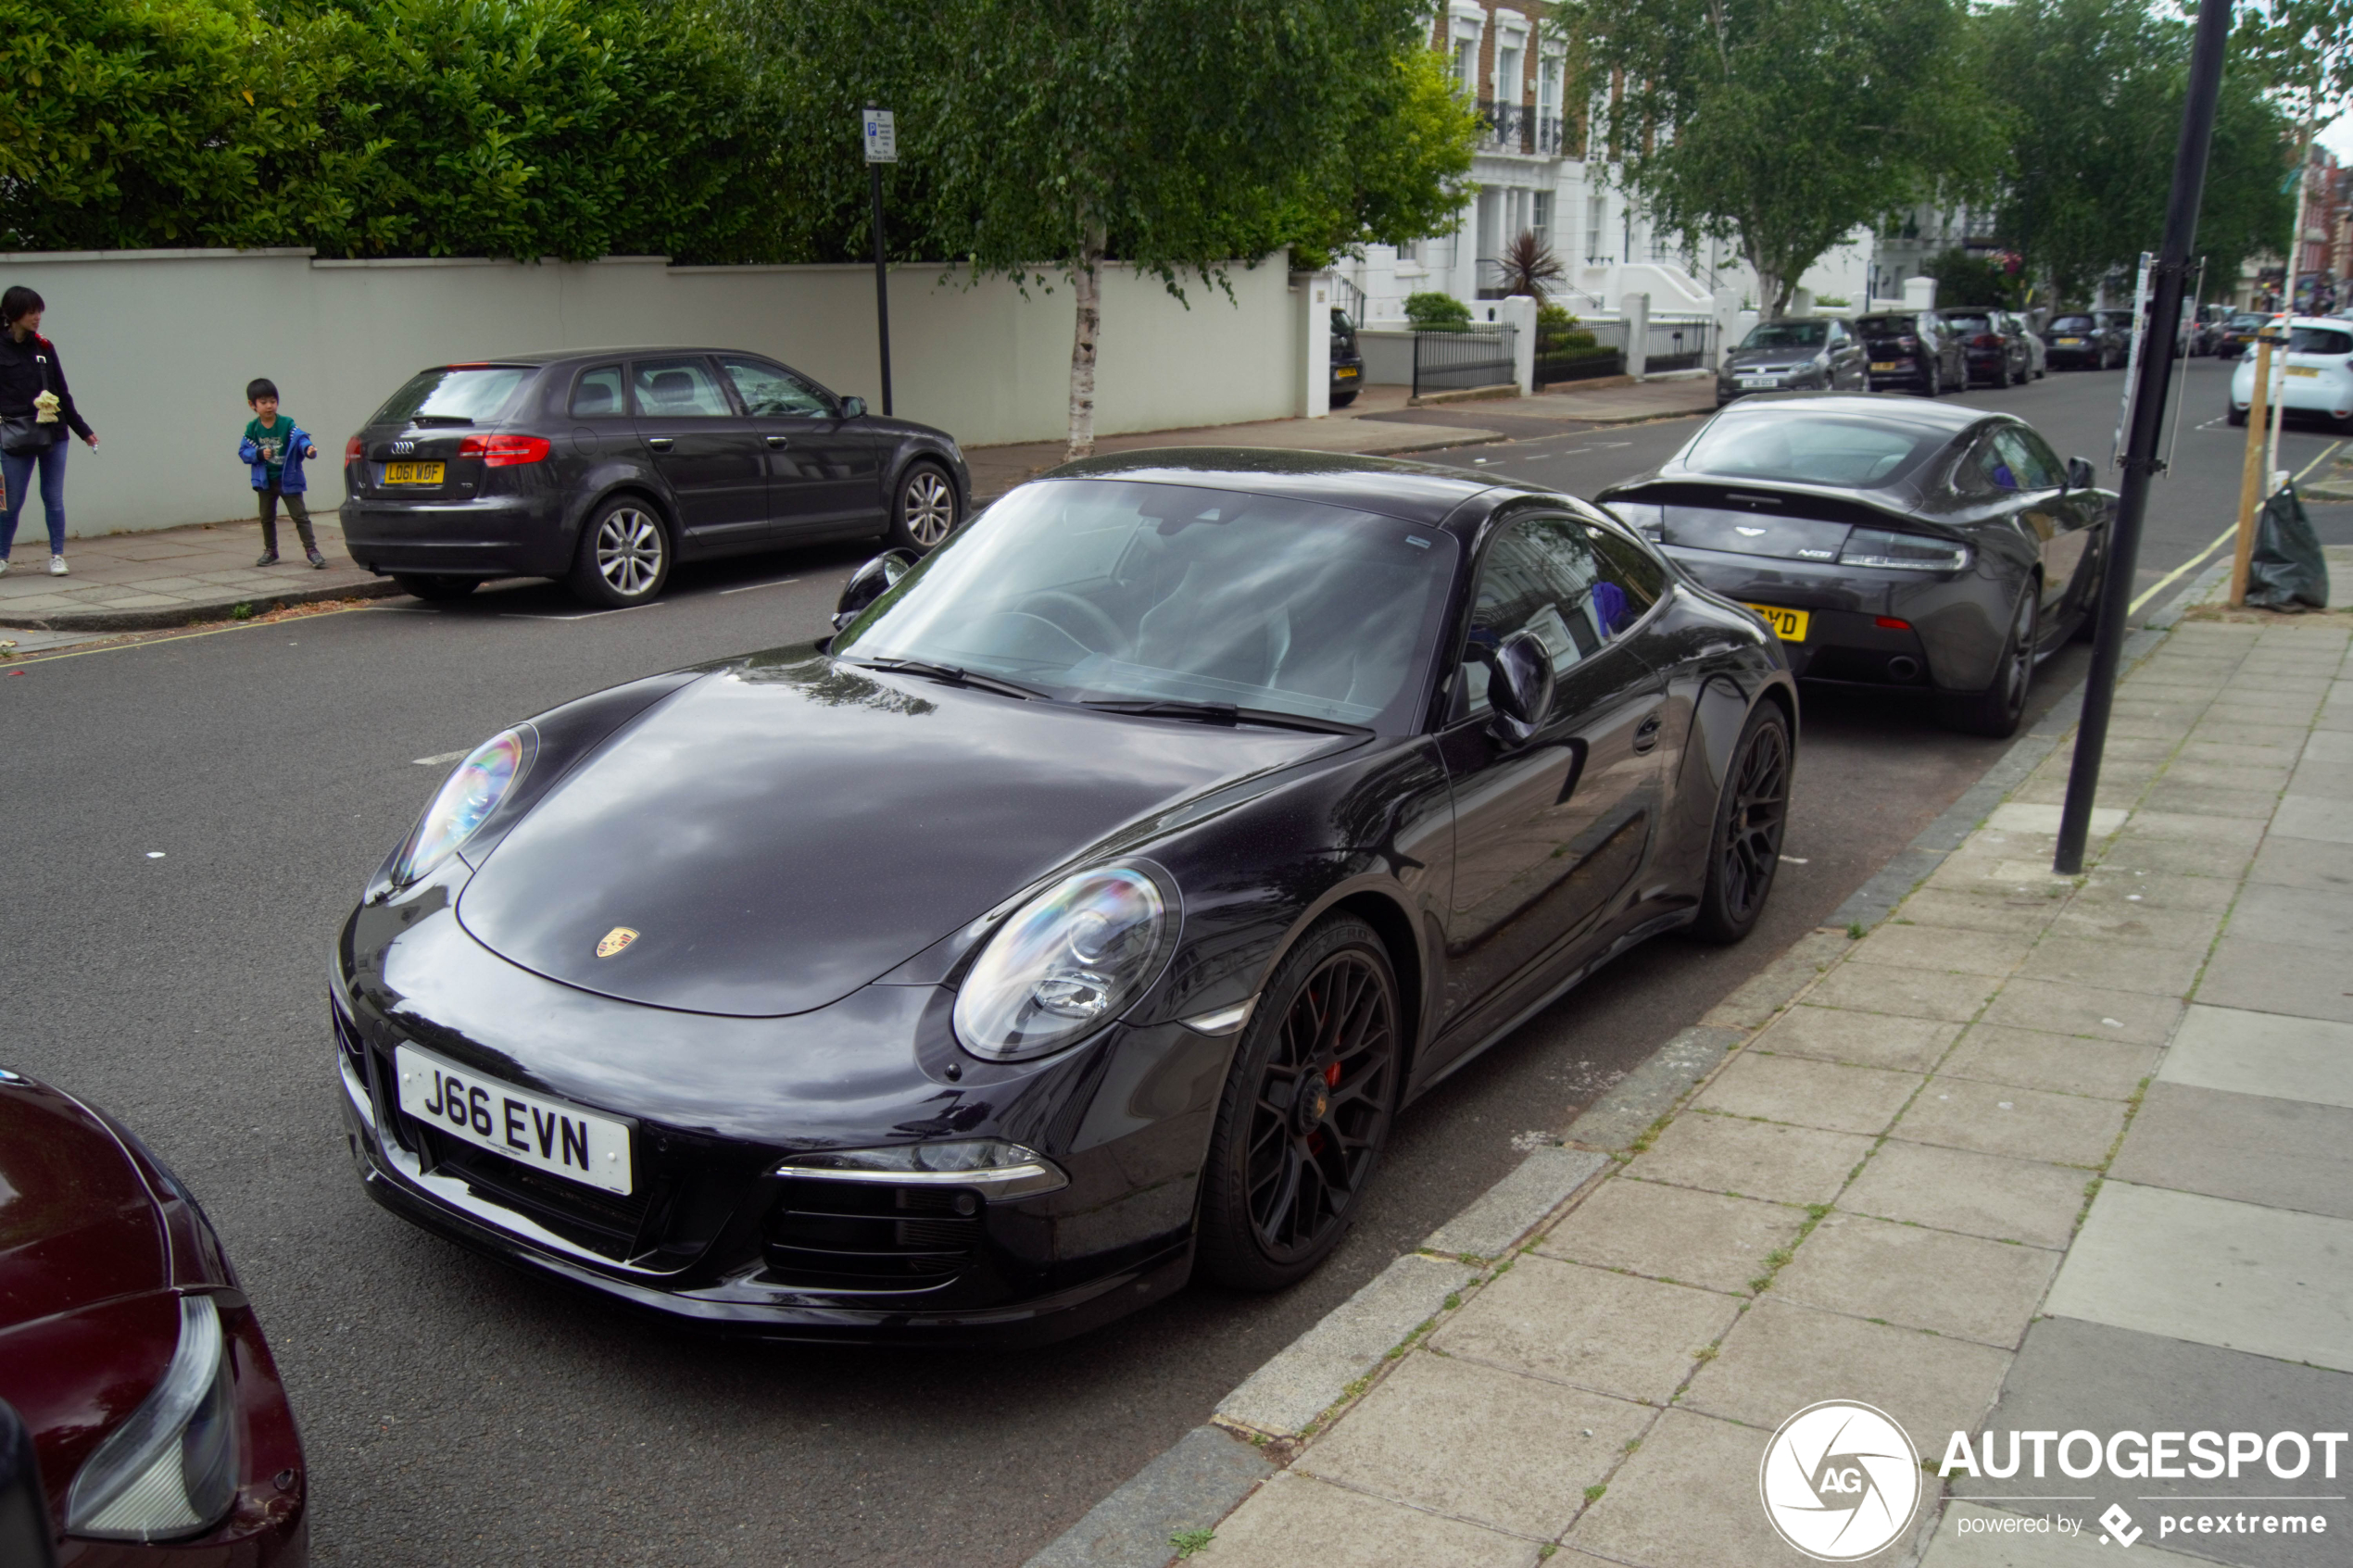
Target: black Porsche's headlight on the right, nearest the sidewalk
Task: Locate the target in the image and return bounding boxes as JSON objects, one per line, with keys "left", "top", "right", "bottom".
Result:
{"left": 955, "top": 868, "right": 1169, "bottom": 1062}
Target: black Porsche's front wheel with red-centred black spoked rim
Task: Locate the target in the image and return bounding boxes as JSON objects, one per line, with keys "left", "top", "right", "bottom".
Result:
{"left": 1200, "top": 914, "right": 1403, "bottom": 1290}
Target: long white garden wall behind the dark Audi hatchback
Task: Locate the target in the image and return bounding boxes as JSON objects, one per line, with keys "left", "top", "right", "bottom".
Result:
{"left": 0, "top": 249, "right": 1306, "bottom": 536}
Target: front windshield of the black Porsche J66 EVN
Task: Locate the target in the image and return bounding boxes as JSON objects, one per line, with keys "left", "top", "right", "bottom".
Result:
{"left": 833, "top": 480, "right": 1456, "bottom": 734}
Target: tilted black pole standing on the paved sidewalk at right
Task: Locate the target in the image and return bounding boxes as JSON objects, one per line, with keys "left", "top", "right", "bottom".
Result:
{"left": 2052, "top": 0, "right": 2231, "bottom": 877}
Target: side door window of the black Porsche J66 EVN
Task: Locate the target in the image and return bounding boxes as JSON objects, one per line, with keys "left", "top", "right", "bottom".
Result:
{"left": 1464, "top": 517, "right": 1656, "bottom": 712}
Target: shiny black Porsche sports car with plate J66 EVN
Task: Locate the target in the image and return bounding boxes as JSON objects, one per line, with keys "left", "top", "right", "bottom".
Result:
{"left": 332, "top": 451, "right": 1795, "bottom": 1340}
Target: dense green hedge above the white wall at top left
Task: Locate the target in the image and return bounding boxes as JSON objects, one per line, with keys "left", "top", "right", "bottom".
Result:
{"left": 0, "top": 0, "right": 776, "bottom": 261}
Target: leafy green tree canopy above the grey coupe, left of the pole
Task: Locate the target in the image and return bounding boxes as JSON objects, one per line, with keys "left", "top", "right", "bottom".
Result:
{"left": 1553, "top": 0, "right": 2003, "bottom": 318}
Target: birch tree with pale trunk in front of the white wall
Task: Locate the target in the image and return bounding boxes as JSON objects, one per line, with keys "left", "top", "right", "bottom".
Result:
{"left": 927, "top": 0, "right": 1426, "bottom": 458}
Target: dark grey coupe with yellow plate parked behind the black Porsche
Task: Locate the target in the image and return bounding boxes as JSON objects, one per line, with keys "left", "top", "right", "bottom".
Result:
{"left": 1598, "top": 395, "right": 2115, "bottom": 735}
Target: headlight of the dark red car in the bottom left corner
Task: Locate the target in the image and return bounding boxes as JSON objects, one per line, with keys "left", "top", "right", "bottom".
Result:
{"left": 66, "top": 1296, "right": 238, "bottom": 1540}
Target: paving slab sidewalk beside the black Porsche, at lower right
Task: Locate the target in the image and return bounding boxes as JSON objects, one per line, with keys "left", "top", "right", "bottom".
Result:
{"left": 1068, "top": 619, "right": 2353, "bottom": 1568}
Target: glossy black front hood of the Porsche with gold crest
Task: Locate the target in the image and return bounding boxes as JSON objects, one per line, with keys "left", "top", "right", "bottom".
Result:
{"left": 459, "top": 656, "right": 1332, "bottom": 1018}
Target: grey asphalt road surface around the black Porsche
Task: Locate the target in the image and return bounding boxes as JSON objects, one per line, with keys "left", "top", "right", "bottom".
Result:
{"left": 0, "top": 367, "right": 2353, "bottom": 1568}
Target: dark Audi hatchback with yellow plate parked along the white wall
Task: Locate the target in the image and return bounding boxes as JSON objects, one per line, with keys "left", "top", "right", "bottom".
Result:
{"left": 341, "top": 348, "right": 972, "bottom": 607}
